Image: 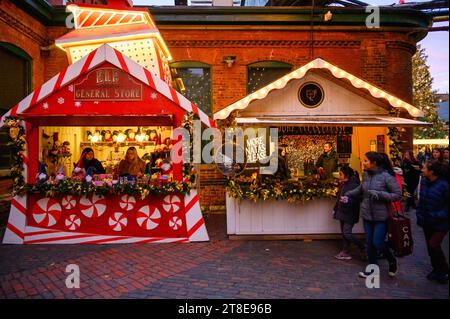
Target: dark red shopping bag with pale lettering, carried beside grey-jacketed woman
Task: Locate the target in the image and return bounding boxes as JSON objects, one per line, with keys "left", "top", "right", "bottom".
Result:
{"left": 388, "top": 201, "right": 414, "bottom": 257}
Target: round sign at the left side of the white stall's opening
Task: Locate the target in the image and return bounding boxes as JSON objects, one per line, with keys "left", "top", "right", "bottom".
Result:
{"left": 215, "top": 143, "right": 247, "bottom": 176}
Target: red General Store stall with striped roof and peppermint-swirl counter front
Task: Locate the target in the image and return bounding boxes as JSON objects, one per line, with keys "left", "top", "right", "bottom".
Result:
{"left": 1, "top": 1, "right": 214, "bottom": 244}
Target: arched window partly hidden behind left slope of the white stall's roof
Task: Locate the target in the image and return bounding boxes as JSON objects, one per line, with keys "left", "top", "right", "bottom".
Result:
{"left": 247, "top": 61, "right": 292, "bottom": 94}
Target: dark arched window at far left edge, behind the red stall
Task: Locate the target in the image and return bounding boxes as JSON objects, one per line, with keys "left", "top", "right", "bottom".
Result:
{"left": 0, "top": 42, "right": 31, "bottom": 175}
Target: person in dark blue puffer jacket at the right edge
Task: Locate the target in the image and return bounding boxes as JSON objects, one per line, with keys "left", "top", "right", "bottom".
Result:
{"left": 416, "top": 160, "right": 449, "bottom": 284}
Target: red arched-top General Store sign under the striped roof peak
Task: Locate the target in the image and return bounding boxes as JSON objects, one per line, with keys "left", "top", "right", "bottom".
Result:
{"left": 74, "top": 68, "right": 142, "bottom": 101}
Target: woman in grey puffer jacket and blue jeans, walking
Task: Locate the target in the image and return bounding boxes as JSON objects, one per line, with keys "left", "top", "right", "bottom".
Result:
{"left": 341, "top": 152, "right": 402, "bottom": 278}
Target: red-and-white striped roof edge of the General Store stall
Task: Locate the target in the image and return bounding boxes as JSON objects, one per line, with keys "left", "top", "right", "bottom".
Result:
{"left": 0, "top": 44, "right": 215, "bottom": 127}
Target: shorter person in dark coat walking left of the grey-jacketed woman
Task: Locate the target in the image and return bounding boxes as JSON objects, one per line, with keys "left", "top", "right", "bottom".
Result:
{"left": 334, "top": 166, "right": 366, "bottom": 260}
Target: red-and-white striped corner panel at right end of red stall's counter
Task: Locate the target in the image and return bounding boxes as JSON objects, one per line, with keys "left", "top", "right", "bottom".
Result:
{"left": 184, "top": 189, "right": 209, "bottom": 242}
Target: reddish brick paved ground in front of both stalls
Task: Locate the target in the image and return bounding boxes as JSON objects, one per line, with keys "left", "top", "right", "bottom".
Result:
{"left": 0, "top": 210, "right": 449, "bottom": 299}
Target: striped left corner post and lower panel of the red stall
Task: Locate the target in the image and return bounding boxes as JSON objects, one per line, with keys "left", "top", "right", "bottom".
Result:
{"left": 3, "top": 121, "right": 29, "bottom": 244}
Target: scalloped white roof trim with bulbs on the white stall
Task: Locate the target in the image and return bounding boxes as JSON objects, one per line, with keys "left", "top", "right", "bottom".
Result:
{"left": 214, "top": 58, "right": 424, "bottom": 120}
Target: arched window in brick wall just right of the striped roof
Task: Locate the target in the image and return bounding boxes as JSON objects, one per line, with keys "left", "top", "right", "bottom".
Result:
{"left": 170, "top": 61, "right": 212, "bottom": 116}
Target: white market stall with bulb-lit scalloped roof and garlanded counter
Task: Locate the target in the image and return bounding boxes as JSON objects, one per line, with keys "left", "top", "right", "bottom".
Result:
{"left": 214, "top": 59, "right": 424, "bottom": 238}
